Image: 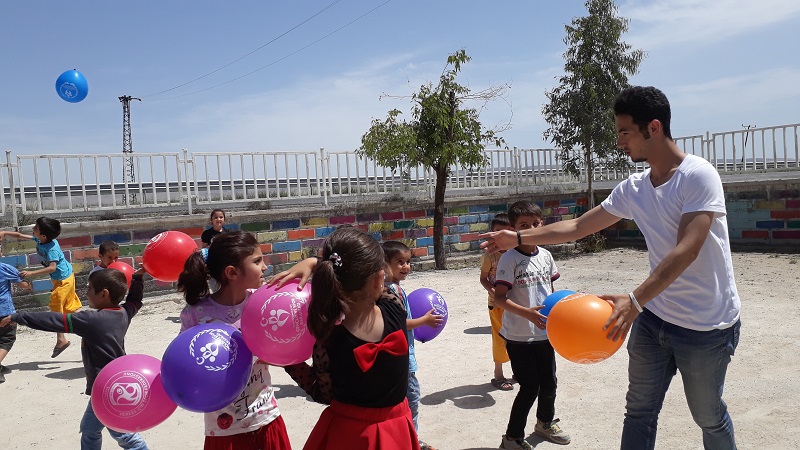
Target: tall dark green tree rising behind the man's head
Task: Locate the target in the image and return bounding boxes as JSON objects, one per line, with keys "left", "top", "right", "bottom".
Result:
{"left": 542, "top": 0, "right": 645, "bottom": 208}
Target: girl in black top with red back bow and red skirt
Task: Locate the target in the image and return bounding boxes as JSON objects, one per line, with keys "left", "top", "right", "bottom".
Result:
{"left": 282, "top": 228, "right": 419, "bottom": 450}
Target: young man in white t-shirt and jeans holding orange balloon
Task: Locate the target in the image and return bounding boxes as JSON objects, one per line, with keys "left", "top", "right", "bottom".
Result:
{"left": 482, "top": 86, "right": 741, "bottom": 450}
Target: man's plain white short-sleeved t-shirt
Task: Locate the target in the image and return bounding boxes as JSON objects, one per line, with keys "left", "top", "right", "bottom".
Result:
{"left": 601, "top": 155, "right": 741, "bottom": 331}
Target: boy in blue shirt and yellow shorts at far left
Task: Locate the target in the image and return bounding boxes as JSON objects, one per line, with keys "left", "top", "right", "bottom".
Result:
{"left": 0, "top": 217, "right": 81, "bottom": 358}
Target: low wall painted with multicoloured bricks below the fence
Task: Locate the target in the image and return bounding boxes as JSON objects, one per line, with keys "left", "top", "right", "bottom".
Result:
{"left": 6, "top": 185, "right": 800, "bottom": 305}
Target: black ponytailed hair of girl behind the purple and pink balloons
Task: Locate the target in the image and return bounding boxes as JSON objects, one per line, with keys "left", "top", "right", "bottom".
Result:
{"left": 178, "top": 230, "right": 259, "bottom": 305}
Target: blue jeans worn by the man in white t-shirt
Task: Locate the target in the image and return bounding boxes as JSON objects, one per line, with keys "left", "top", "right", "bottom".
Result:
{"left": 620, "top": 310, "right": 741, "bottom": 450}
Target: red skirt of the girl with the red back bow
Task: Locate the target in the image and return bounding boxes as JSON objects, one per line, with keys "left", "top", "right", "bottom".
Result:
{"left": 303, "top": 400, "right": 419, "bottom": 450}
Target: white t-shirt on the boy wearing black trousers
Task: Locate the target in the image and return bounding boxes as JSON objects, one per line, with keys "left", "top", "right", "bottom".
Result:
{"left": 495, "top": 247, "right": 559, "bottom": 342}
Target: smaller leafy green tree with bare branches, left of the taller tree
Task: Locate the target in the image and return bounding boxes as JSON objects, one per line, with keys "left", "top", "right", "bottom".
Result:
{"left": 357, "top": 49, "right": 508, "bottom": 269}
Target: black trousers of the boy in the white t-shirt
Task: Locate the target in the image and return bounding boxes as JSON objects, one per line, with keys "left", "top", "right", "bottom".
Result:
{"left": 506, "top": 341, "right": 558, "bottom": 438}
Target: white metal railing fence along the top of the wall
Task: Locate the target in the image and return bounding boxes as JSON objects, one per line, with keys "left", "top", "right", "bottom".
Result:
{"left": 0, "top": 124, "right": 800, "bottom": 226}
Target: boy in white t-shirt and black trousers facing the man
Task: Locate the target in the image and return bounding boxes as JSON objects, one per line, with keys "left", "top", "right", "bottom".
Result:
{"left": 494, "top": 201, "right": 570, "bottom": 450}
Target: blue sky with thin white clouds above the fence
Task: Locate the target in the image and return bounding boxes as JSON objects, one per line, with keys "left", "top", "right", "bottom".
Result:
{"left": 0, "top": 0, "right": 800, "bottom": 154}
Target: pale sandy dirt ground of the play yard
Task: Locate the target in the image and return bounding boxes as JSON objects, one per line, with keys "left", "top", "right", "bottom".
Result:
{"left": 0, "top": 249, "right": 800, "bottom": 450}
